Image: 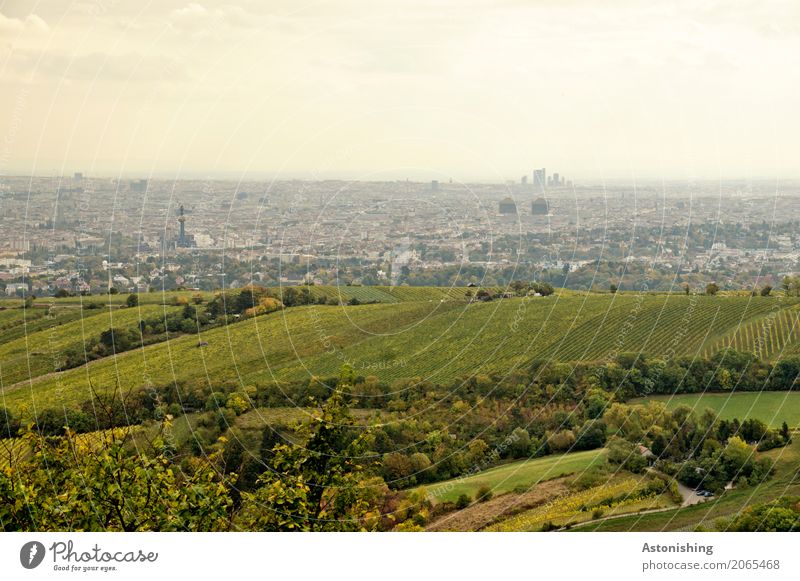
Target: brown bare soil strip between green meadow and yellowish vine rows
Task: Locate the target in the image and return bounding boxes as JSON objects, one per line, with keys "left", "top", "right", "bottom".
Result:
{"left": 425, "top": 477, "right": 570, "bottom": 532}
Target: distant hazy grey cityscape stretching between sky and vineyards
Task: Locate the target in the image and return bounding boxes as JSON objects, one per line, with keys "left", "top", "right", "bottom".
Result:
{"left": 0, "top": 168, "right": 800, "bottom": 296}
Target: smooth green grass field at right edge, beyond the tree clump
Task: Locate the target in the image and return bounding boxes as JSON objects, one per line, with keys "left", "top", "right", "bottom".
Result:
{"left": 630, "top": 391, "right": 800, "bottom": 428}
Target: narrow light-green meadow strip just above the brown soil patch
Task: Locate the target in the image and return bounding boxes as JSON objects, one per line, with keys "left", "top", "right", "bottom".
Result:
{"left": 418, "top": 449, "right": 605, "bottom": 502}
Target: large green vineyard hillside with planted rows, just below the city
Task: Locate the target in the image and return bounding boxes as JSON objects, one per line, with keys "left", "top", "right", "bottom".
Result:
{"left": 0, "top": 287, "right": 797, "bottom": 409}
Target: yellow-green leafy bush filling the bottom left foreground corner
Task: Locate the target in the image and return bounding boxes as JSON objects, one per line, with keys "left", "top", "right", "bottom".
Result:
{"left": 0, "top": 420, "right": 235, "bottom": 532}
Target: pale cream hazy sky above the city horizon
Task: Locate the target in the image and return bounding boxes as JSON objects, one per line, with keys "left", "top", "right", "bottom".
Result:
{"left": 0, "top": 0, "right": 800, "bottom": 180}
